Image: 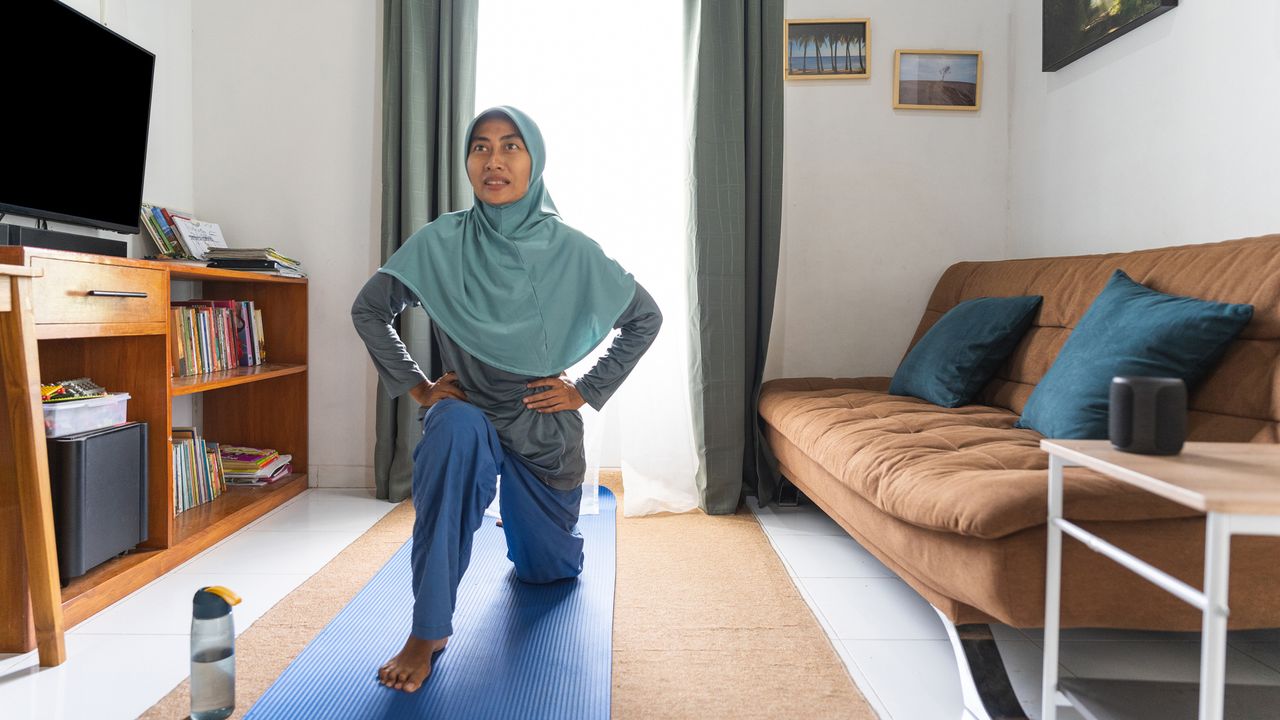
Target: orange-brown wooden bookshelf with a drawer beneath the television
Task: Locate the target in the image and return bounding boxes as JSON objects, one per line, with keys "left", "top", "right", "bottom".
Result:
{"left": 0, "top": 247, "right": 307, "bottom": 652}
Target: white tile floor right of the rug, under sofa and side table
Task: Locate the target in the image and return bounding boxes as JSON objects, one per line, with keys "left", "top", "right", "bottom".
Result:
{"left": 749, "top": 491, "right": 1280, "bottom": 720}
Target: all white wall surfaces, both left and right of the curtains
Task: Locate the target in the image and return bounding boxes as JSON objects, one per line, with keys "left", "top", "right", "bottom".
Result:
{"left": 99, "top": 0, "right": 1280, "bottom": 486}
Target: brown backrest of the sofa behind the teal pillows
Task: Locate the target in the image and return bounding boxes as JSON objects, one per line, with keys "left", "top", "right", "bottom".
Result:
{"left": 913, "top": 234, "right": 1280, "bottom": 442}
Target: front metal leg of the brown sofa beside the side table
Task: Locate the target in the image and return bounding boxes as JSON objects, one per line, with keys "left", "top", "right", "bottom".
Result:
{"left": 934, "top": 609, "right": 1027, "bottom": 720}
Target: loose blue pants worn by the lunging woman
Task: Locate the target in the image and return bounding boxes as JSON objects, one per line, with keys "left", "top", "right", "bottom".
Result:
{"left": 411, "top": 400, "right": 582, "bottom": 639}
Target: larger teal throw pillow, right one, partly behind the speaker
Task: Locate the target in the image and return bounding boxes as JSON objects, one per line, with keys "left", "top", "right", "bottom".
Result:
{"left": 1015, "top": 270, "right": 1253, "bottom": 439}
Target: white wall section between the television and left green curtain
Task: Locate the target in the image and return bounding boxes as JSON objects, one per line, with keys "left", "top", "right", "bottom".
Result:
{"left": 191, "top": 0, "right": 381, "bottom": 487}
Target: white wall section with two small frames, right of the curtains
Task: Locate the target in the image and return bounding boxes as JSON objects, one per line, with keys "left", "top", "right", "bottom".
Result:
{"left": 765, "top": 0, "right": 1018, "bottom": 378}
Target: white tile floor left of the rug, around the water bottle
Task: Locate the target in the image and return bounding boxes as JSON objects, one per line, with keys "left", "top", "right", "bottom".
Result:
{"left": 0, "top": 488, "right": 394, "bottom": 720}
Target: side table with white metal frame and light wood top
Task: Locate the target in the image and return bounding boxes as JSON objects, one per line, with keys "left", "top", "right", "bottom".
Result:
{"left": 1041, "top": 439, "right": 1280, "bottom": 720}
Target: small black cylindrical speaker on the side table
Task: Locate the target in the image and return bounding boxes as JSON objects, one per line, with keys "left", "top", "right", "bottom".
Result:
{"left": 1108, "top": 377, "right": 1187, "bottom": 455}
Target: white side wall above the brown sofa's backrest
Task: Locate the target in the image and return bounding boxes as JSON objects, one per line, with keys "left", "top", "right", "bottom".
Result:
{"left": 1010, "top": 0, "right": 1280, "bottom": 256}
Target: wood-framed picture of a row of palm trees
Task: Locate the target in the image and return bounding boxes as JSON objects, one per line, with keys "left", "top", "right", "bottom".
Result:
{"left": 782, "top": 18, "right": 872, "bottom": 79}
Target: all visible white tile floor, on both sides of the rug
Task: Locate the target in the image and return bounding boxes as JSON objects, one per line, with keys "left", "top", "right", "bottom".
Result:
{"left": 0, "top": 488, "right": 1280, "bottom": 720}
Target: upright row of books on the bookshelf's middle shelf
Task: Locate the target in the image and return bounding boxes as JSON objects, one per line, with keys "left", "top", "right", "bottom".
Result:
{"left": 169, "top": 300, "right": 266, "bottom": 377}
